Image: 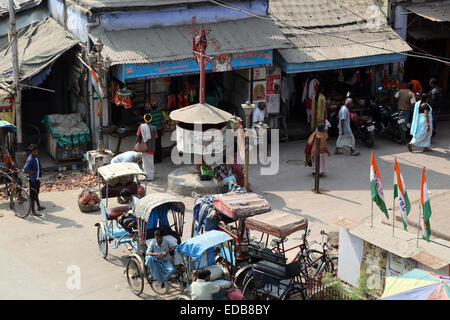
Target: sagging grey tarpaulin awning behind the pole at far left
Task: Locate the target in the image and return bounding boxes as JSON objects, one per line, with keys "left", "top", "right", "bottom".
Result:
{"left": 0, "top": 18, "right": 80, "bottom": 82}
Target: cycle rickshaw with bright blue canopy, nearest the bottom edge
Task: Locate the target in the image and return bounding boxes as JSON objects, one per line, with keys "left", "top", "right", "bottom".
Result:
{"left": 175, "top": 230, "right": 241, "bottom": 300}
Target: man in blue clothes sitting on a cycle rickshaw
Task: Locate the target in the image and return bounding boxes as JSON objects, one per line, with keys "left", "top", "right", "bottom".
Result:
{"left": 145, "top": 229, "right": 177, "bottom": 287}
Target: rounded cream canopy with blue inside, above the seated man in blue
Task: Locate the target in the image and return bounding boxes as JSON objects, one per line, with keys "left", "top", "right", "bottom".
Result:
{"left": 134, "top": 193, "right": 185, "bottom": 223}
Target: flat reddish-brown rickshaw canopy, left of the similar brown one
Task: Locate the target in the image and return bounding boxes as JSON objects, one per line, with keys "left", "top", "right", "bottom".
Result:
{"left": 214, "top": 193, "right": 271, "bottom": 219}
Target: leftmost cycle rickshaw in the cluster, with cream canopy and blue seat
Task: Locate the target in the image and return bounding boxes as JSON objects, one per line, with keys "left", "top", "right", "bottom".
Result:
{"left": 95, "top": 163, "right": 147, "bottom": 259}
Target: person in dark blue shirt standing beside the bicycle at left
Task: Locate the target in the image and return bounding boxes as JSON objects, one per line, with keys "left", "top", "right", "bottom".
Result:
{"left": 23, "top": 144, "right": 45, "bottom": 217}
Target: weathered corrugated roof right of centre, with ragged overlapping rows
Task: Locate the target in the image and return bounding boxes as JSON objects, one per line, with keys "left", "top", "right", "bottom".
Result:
{"left": 269, "top": 0, "right": 411, "bottom": 63}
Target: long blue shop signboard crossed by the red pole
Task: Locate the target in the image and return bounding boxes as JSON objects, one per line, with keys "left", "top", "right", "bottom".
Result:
{"left": 113, "top": 50, "right": 272, "bottom": 82}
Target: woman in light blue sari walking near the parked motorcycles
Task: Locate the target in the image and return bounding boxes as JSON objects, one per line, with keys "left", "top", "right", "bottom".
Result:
{"left": 408, "top": 93, "right": 433, "bottom": 152}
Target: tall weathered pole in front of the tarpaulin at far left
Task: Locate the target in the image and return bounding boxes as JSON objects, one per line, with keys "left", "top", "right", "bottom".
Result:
{"left": 9, "top": 0, "right": 23, "bottom": 151}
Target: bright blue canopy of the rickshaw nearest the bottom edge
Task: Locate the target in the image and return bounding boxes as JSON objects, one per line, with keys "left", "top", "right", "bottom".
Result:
{"left": 176, "top": 230, "right": 233, "bottom": 263}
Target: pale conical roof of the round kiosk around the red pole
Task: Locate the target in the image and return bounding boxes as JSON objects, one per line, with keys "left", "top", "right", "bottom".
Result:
{"left": 170, "top": 103, "right": 234, "bottom": 124}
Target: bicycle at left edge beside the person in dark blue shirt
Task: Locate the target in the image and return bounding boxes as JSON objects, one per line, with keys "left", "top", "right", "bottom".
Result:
{"left": 0, "top": 168, "right": 31, "bottom": 219}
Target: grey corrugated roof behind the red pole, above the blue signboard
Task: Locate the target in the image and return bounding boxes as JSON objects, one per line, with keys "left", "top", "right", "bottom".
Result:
{"left": 93, "top": 18, "right": 290, "bottom": 65}
